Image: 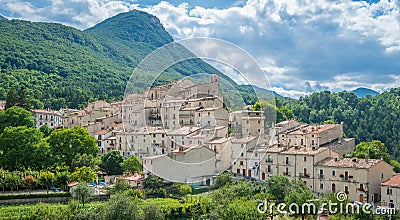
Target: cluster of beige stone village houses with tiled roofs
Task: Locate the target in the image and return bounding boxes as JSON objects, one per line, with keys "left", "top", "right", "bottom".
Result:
{"left": 28, "top": 75, "right": 400, "bottom": 205}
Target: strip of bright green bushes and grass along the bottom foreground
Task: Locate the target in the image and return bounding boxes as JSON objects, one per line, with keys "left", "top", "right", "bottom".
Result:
{"left": 0, "top": 176, "right": 398, "bottom": 220}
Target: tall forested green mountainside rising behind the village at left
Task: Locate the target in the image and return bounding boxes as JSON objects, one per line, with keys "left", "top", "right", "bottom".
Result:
{"left": 0, "top": 10, "right": 254, "bottom": 109}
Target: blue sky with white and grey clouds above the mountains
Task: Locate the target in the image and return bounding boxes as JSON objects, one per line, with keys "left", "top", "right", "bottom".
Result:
{"left": 0, "top": 0, "right": 400, "bottom": 97}
